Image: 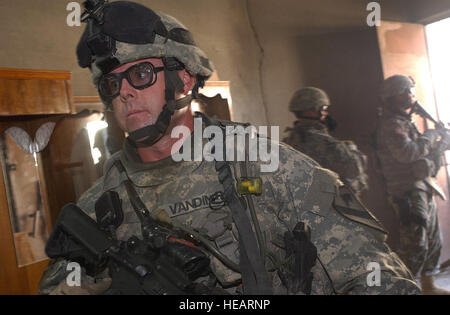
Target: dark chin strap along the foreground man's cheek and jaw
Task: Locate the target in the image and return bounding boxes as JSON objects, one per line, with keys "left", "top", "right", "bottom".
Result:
{"left": 127, "top": 57, "right": 192, "bottom": 147}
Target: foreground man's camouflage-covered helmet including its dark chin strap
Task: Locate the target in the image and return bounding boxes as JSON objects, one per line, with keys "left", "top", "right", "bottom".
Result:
{"left": 77, "top": 0, "right": 214, "bottom": 146}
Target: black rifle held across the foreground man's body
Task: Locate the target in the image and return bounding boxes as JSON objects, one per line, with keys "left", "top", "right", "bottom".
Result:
{"left": 46, "top": 204, "right": 214, "bottom": 295}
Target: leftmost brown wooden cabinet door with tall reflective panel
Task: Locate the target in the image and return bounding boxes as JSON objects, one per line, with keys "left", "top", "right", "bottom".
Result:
{"left": 0, "top": 129, "right": 51, "bottom": 294}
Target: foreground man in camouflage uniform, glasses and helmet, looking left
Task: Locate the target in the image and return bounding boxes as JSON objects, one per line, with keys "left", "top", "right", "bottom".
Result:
{"left": 40, "top": 2, "right": 420, "bottom": 294}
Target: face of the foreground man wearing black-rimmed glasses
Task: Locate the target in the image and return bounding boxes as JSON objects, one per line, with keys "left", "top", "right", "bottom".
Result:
{"left": 111, "top": 58, "right": 166, "bottom": 132}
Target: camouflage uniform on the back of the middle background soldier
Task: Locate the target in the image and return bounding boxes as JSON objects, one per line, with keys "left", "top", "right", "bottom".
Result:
{"left": 283, "top": 119, "right": 368, "bottom": 195}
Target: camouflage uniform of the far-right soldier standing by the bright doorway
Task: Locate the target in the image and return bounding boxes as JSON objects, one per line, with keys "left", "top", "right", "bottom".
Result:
{"left": 377, "top": 109, "right": 442, "bottom": 277}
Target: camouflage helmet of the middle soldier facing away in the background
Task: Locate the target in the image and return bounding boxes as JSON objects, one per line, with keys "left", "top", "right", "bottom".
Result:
{"left": 289, "top": 87, "right": 330, "bottom": 112}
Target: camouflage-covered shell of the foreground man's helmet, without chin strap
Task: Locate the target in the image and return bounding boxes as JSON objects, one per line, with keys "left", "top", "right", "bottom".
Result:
{"left": 77, "top": 1, "right": 214, "bottom": 85}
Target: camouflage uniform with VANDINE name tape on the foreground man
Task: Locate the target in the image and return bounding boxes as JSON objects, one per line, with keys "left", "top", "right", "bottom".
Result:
{"left": 41, "top": 119, "right": 420, "bottom": 294}
